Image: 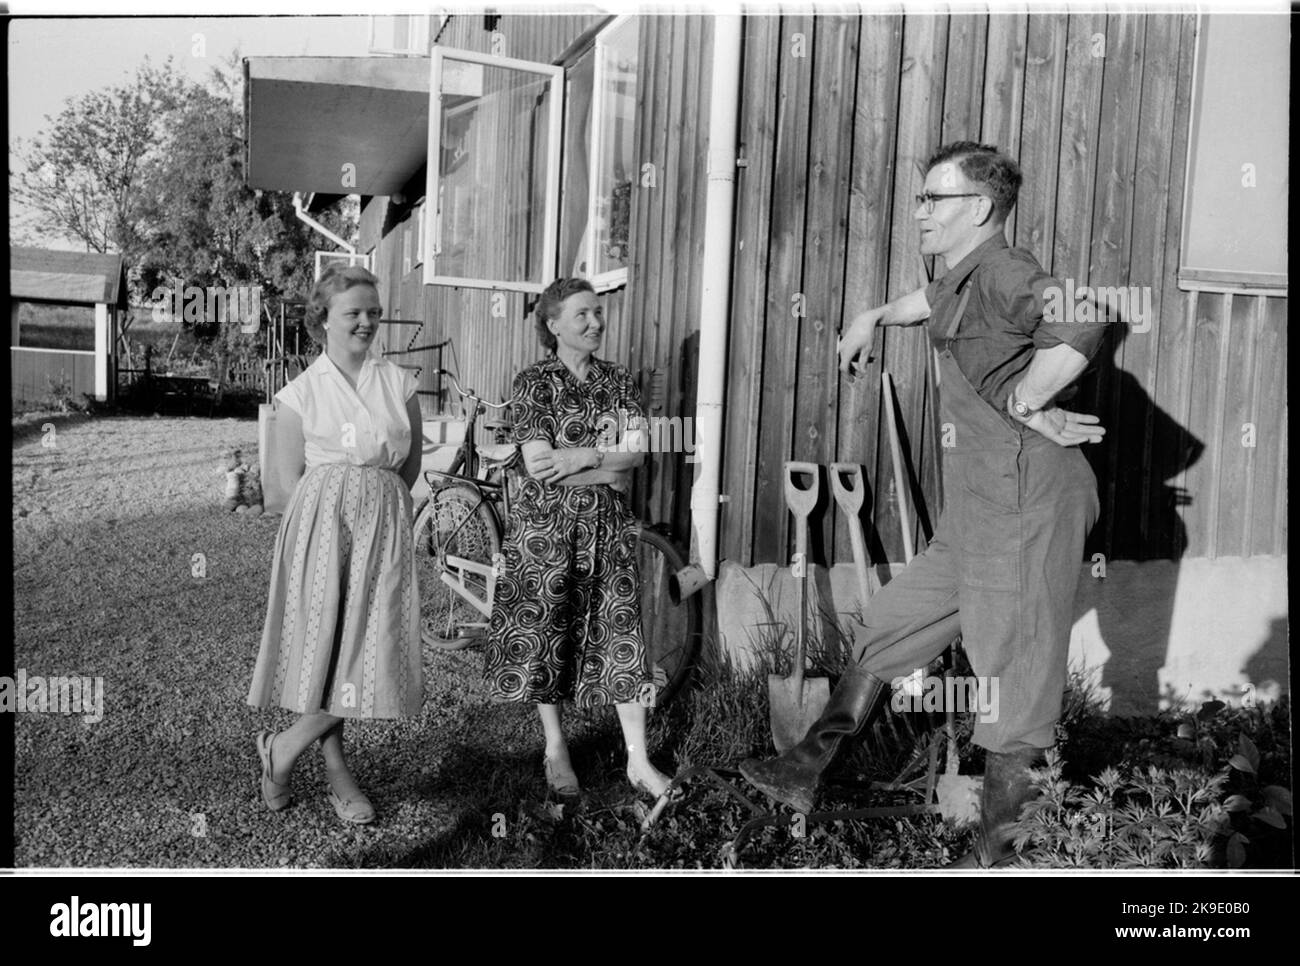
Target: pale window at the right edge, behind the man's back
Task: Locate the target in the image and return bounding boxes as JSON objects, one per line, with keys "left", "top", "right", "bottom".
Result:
{"left": 1178, "top": 13, "right": 1291, "bottom": 295}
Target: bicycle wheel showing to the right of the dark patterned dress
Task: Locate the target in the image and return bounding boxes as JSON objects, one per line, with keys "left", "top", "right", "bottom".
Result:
{"left": 637, "top": 524, "right": 702, "bottom": 707}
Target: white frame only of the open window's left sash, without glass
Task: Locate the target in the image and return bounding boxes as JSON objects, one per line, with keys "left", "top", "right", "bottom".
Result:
{"left": 424, "top": 46, "right": 564, "bottom": 294}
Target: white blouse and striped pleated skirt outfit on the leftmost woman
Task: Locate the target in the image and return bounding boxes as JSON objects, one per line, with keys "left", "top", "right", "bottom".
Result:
{"left": 248, "top": 352, "right": 424, "bottom": 718}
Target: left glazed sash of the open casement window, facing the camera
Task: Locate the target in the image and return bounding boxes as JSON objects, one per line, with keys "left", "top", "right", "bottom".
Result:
{"left": 424, "top": 47, "right": 564, "bottom": 293}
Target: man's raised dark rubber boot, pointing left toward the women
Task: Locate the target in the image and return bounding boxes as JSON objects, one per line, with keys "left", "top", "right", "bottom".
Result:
{"left": 740, "top": 663, "right": 885, "bottom": 815}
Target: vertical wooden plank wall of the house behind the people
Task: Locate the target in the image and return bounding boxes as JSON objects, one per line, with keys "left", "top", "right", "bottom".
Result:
{"left": 363, "top": 12, "right": 1287, "bottom": 564}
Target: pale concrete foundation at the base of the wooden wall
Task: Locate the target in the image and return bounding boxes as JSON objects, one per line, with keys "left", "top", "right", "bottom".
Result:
{"left": 716, "top": 556, "right": 1290, "bottom": 715}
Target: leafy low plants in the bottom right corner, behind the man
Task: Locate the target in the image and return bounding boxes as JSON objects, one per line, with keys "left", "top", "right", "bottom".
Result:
{"left": 1017, "top": 701, "right": 1292, "bottom": 868}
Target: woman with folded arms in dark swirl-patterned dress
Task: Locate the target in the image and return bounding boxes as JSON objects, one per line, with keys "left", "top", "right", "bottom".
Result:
{"left": 484, "top": 278, "right": 668, "bottom": 796}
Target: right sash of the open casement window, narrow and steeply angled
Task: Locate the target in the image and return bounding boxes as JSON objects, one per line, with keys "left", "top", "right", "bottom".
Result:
{"left": 559, "top": 17, "right": 637, "bottom": 291}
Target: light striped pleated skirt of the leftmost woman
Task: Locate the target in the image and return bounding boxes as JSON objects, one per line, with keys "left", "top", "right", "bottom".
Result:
{"left": 248, "top": 463, "right": 424, "bottom": 718}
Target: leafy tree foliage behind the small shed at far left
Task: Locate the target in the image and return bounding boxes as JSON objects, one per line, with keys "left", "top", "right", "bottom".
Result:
{"left": 16, "top": 52, "right": 356, "bottom": 400}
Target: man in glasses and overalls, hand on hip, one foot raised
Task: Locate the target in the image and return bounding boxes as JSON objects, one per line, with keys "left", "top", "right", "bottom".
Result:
{"left": 741, "top": 142, "right": 1105, "bottom": 867}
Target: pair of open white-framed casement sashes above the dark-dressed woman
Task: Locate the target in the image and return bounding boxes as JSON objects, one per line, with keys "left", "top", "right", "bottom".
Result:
{"left": 424, "top": 17, "right": 638, "bottom": 293}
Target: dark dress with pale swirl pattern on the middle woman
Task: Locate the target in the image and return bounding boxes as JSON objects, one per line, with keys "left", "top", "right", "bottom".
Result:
{"left": 484, "top": 358, "right": 653, "bottom": 707}
